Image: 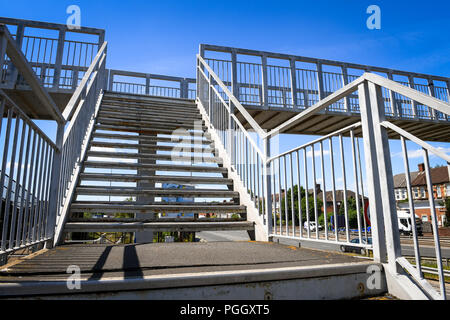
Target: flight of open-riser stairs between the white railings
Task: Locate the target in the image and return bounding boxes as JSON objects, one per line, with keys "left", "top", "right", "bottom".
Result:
{"left": 64, "top": 93, "right": 254, "bottom": 238}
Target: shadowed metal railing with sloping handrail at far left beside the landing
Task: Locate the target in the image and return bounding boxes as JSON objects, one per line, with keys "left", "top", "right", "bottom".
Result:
{"left": 0, "top": 25, "right": 65, "bottom": 255}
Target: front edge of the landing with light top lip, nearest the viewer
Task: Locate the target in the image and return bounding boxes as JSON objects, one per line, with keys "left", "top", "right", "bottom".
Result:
{"left": 0, "top": 262, "right": 387, "bottom": 299}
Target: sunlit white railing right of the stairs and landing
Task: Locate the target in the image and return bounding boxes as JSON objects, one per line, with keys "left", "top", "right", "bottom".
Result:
{"left": 197, "top": 47, "right": 450, "bottom": 299}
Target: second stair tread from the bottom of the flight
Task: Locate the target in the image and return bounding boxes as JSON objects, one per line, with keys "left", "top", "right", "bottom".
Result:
{"left": 70, "top": 201, "right": 246, "bottom": 214}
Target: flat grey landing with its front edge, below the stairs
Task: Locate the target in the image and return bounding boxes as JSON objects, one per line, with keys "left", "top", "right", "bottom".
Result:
{"left": 0, "top": 241, "right": 387, "bottom": 300}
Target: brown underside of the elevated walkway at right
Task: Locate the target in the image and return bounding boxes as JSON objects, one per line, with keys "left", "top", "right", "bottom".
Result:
{"left": 237, "top": 105, "right": 450, "bottom": 142}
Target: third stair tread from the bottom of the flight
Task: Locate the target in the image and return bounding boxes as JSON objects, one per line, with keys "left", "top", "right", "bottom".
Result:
{"left": 76, "top": 186, "right": 239, "bottom": 198}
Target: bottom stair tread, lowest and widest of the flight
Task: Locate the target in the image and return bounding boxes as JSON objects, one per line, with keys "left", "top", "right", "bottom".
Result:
{"left": 64, "top": 221, "right": 255, "bottom": 232}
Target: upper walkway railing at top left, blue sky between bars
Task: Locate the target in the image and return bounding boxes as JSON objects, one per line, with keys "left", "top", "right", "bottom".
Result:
{"left": 0, "top": 17, "right": 105, "bottom": 91}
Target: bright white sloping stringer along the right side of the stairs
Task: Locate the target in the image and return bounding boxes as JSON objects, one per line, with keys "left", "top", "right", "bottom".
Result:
{"left": 196, "top": 99, "right": 269, "bottom": 242}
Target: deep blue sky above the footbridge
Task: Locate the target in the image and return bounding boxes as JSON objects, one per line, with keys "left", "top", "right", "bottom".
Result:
{"left": 0, "top": 0, "right": 450, "bottom": 192}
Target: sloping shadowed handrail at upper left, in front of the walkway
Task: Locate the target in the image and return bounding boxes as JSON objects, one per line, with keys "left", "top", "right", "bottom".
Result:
{"left": 0, "top": 24, "right": 65, "bottom": 123}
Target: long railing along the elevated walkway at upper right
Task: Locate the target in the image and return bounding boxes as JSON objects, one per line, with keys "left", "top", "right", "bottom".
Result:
{"left": 200, "top": 44, "right": 450, "bottom": 121}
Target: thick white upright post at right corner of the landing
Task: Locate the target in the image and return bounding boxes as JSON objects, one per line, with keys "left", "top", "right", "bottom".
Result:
{"left": 358, "top": 82, "right": 401, "bottom": 272}
